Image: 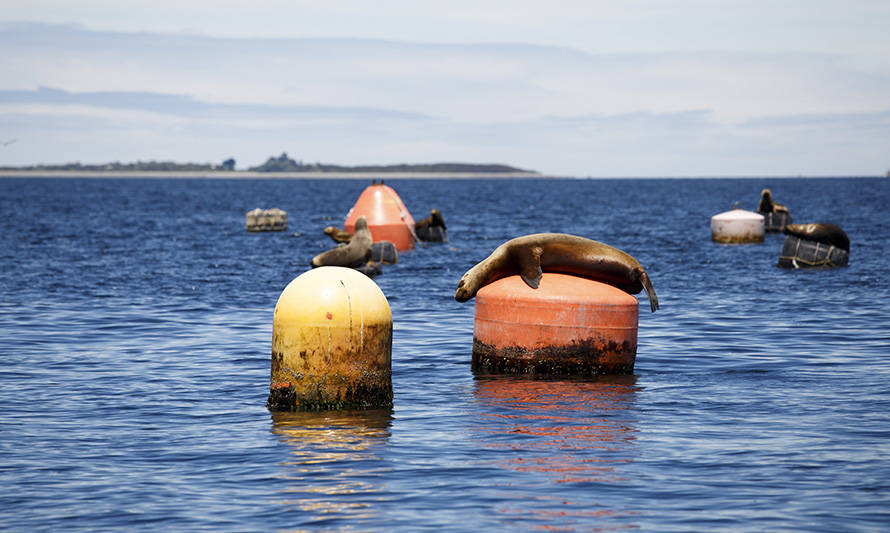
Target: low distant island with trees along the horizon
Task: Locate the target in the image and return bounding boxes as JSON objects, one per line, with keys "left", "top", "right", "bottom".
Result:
{"left": 0, "top": 152, "right": 537, "bottom": 174}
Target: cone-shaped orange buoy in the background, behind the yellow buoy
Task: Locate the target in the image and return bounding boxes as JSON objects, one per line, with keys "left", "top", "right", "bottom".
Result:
{"left": 343, "top": 183, "right": 414, "bottom": 252}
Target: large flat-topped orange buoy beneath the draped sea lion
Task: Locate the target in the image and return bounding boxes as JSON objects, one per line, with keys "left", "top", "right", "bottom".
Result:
{"left": 473, "top": 272, "right": 639, "bottom": 375}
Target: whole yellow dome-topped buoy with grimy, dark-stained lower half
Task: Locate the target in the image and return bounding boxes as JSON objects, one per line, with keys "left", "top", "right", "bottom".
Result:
{"left": 267, "top": 266, "right": 392, "bottom": 410}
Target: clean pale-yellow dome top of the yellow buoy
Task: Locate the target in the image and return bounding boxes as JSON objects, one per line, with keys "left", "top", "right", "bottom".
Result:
{"left": 274, "top": 266, "right": 392, "bottom": 327}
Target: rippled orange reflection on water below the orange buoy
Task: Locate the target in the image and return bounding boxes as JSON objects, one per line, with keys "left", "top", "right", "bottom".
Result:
{"left": 474, "top": 376, "right": 637, "bottom": 529}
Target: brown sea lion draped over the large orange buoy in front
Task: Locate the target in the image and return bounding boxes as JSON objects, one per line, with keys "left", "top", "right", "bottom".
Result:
{"left": 454, "top": 233, "right": 658, "bottom": 313}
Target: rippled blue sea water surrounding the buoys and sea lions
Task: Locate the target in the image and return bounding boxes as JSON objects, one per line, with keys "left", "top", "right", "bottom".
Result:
{"left": 0, "top": 178, "right": 890, "bottom": 531}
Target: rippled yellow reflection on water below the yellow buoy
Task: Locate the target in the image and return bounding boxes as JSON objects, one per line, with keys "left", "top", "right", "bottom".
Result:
{"left": 272, "top": 409, "right": 392, "bottom": 525}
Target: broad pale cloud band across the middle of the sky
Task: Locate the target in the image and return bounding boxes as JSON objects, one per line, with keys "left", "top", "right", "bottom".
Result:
{"left": 0, "top": 24, "right": 890, "bottom": 121}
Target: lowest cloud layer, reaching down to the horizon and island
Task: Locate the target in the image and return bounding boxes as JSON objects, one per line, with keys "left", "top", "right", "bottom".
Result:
{"left": 0, "top": 89, "right": 890, "bottom": 176}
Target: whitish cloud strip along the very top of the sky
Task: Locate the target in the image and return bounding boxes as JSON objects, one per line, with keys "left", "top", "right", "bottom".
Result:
{"left": 0, "top": 0, "right": 890, "bottom": 59}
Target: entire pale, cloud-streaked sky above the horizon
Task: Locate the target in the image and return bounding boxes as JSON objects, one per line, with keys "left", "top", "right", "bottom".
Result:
{"left": 0, "top": 0, "right": 890, "bottom": 177}
